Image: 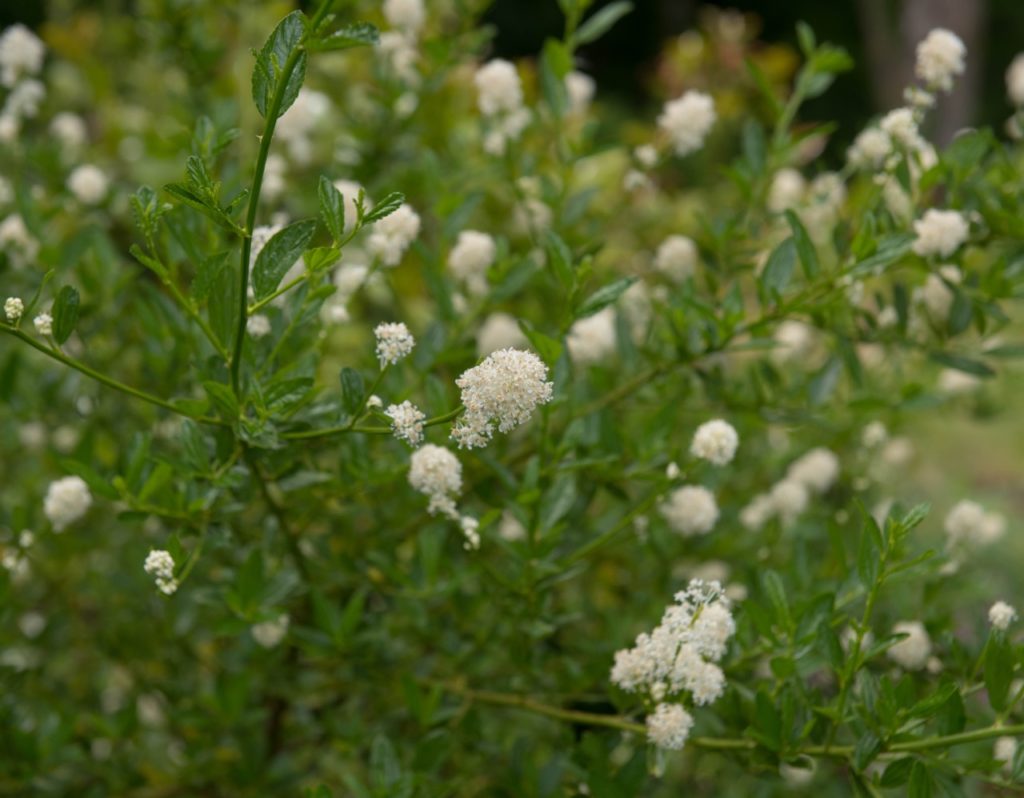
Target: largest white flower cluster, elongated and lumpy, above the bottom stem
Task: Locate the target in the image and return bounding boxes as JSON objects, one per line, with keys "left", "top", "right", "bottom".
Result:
{"left": 610, "top": 580, "right": 736, "bottom": 750}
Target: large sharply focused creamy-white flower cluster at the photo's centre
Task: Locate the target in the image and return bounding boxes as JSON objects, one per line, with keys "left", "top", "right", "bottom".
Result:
{"left": 452, "top": 349, "right": 554, "bottom": 449}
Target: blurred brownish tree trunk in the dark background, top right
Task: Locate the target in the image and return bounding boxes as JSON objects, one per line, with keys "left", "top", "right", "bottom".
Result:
{"left": 857, "top": 0, "right": 988, "bottom": 144}
